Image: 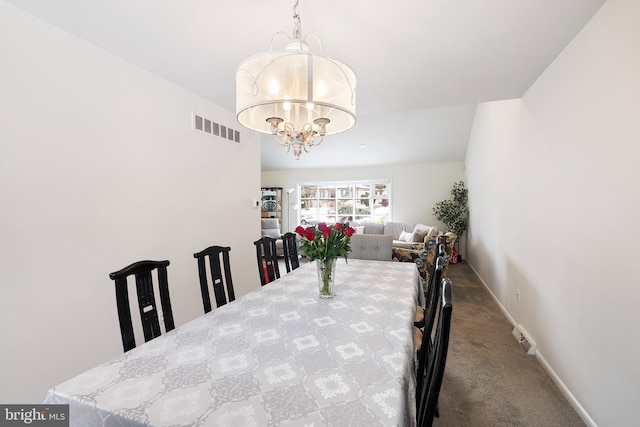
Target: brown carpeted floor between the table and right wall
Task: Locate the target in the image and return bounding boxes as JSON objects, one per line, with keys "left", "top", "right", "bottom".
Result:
{"left": 434, "top": 262, "right": 585, "bottom": 427}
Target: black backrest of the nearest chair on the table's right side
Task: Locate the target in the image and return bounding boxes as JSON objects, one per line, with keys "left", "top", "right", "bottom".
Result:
{"left": 417, "top": 279, "right": 453, "bottom": 426}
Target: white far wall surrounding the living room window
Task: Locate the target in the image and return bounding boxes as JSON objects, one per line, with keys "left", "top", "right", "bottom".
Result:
{"left": 262, "top": 161, "right": 464, "bottom": 232}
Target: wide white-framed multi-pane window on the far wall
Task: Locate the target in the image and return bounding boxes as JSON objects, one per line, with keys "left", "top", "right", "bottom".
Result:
{"left": 297, "top": 180, "right": 391, "bottom": 225}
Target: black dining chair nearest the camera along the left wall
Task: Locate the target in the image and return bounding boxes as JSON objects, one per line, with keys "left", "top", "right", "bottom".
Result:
{"left": 109, "top": 261, "right": 175, "bottom": 352}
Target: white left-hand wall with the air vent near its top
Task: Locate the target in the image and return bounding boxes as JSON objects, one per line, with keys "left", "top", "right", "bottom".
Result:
{"left": 0, "top": 2, "right": 260, "bottom": 403}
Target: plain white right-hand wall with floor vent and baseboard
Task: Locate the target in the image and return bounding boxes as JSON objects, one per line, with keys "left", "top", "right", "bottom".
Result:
{"left": 466, "top": 0, "right": 640, "bottom": 427}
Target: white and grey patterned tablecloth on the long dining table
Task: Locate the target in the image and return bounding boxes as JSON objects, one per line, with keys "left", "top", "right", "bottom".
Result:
{"left": 45, "top": 259, "right": 420, "bottom": 427}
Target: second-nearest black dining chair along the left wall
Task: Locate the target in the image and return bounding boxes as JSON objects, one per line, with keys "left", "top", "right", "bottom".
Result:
{"left": 193, "top": 246, "right": 236, "bottom": 314}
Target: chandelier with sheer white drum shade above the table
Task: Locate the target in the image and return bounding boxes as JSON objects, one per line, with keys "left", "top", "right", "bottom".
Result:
{"left": 236, "top": 0, "right": 356, "bottom": 160}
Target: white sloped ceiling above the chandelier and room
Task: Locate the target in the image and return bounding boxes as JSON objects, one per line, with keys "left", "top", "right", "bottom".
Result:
{"left": 5, "top": 0, "right": 605, "bottom": 170}
